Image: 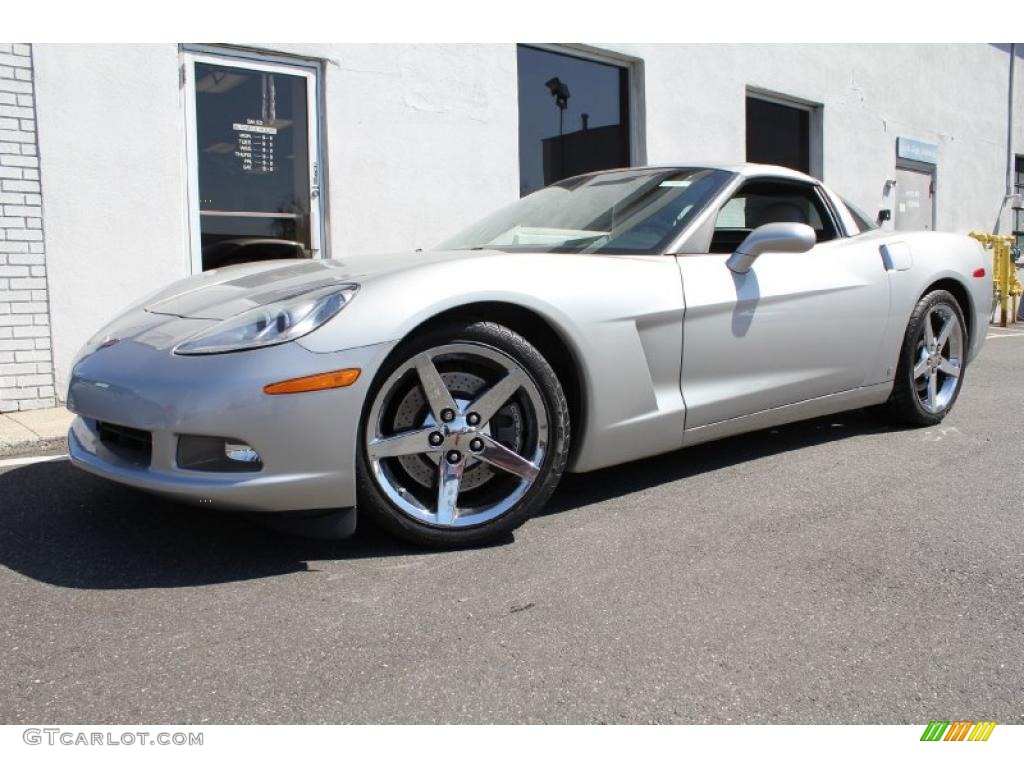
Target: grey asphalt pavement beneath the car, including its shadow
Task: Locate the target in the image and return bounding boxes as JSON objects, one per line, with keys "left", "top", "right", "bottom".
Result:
{"left": 0, "top": 331, "right": 1024, "bottom": 724}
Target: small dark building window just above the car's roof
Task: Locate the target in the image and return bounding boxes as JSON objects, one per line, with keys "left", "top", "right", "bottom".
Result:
{"left": 746, "top": 96, "right": 811, "bottom": 173}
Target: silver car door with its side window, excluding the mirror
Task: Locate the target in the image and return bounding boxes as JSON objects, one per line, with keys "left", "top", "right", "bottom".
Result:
{"left": 678, "top": 178, "right": 889, "bottom": 429}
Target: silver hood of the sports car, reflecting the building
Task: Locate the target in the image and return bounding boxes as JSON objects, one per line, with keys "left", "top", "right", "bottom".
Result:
{"left": 142, "top": 251, "right": 497, "bottom": 321}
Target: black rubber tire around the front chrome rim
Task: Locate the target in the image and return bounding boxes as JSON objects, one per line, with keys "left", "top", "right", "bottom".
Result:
{"left": 356, "top": 319, "right": 570, "bottom": 548}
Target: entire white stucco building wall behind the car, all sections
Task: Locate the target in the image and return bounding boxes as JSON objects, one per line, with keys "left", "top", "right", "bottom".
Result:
{"left": 25, "top": 44, "right": 1024, "bottom": 403}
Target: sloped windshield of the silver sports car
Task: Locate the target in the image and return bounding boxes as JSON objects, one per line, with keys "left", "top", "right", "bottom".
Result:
{"left": 438, "top": 168, "right": 732, "bottom": 254}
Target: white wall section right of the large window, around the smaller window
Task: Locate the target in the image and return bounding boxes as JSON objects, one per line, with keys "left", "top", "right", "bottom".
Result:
{"left": 606, "top": 45, "right": 1009, "bottom": 231}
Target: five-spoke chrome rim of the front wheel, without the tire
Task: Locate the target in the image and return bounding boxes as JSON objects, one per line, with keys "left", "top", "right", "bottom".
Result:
{"left": 365, "top": 343, "right": 548, "bottom": 528}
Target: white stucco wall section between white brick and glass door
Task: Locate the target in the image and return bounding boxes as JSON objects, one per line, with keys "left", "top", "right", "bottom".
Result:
{"left": 34, "top": 45, "right": 189, "bottom": 396}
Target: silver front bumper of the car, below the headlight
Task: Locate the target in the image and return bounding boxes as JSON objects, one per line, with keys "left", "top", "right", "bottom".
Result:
{"left": 68, "top": 341, "right": 391, "bottom": 512}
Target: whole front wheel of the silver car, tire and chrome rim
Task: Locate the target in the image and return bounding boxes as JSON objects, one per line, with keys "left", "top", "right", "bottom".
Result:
{"left": 358, "top": 322, "right": 569, "bottom": 547}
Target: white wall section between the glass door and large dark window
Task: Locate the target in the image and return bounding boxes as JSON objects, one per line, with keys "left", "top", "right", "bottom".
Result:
{"left": 272, "top": 45, "right": 519, "bottom": 258}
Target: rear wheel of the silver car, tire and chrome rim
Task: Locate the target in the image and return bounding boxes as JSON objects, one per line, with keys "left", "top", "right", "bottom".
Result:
{"left": 888, "top": 291, "right": 968, "bottom": 427}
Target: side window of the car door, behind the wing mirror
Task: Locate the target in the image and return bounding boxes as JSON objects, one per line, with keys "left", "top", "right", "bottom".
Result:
{"left": 711, "top": 180, "right": 837, "bottom": 253}
